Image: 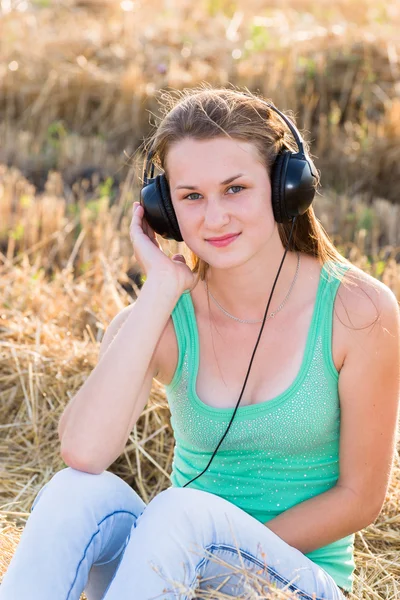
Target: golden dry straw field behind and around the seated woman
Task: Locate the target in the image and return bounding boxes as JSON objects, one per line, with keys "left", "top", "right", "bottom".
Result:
{"left": 0, "top": 0, "right": 400, "bottom": 600}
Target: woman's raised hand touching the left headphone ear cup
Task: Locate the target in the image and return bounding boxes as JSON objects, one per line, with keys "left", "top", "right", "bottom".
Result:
{"left": 129, "top": 202, "right": 195, "bottom": 293}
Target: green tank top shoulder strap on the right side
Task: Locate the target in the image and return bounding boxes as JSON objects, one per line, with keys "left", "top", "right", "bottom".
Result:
{"left": 316, "top": 260, "right": 351, "bottom": 380}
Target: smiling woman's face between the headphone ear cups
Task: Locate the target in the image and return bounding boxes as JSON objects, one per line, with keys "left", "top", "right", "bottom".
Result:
{"left": 166, "top": 137, "right": 275, "bottom": 268}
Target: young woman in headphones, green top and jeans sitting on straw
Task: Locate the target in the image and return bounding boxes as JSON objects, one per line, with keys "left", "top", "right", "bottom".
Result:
{"left": 0, "top": 86, "right": 400, "bottom": 600}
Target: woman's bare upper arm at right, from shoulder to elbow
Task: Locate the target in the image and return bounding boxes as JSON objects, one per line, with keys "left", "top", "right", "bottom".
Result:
{"left": 337, "top": 284, "right": 400, "bottom": 520}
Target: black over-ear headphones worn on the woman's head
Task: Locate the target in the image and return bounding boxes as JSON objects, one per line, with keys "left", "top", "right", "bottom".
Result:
{"left": 140, "top": 98, "right": 317, "bottom": 242}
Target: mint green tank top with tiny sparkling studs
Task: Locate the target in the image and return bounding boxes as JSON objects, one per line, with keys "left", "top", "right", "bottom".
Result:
{"left": 165, "top": 263, "right": 355, "bottom": 591}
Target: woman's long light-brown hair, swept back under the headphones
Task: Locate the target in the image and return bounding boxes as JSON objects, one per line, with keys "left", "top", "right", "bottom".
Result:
{"left": 140, "top": 83, "right": 378, "bottom": 322}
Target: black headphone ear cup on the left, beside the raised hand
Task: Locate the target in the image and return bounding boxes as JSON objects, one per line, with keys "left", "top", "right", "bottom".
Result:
{"left": 140, "top": 175, "right": 183, "bottom": 242}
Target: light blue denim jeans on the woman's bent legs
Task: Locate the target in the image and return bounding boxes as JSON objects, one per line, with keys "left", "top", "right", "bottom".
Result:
{"left": 0, "top": 467, "right": 344, "bottom": 600}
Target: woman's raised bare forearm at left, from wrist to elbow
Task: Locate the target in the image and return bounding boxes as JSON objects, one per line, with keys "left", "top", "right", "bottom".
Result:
{"left": 59, "top": 278, "right": 179, "bottom": 473}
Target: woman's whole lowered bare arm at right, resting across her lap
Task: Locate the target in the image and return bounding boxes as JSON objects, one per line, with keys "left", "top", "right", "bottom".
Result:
{"left": 266, "top": 284, "right": 400, "bottom": 553}
